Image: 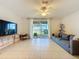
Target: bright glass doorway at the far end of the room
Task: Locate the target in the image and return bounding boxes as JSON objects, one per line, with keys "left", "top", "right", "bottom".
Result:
{"left": 32, "top": 20, "right": 48, "bottom": 38}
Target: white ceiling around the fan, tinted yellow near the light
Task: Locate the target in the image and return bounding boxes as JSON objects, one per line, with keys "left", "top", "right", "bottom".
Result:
{"left": 0, "top": 0, "right": 79, "bottom": 18}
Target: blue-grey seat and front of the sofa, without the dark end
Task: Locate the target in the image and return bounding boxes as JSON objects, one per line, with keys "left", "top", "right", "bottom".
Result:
{"left": 51, "top": 36, "right": 70, "bottom": 52}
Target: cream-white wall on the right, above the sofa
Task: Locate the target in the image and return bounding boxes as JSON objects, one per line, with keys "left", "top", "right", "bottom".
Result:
{"left": 62, "top": 11, "right": 79, "bottom": 37}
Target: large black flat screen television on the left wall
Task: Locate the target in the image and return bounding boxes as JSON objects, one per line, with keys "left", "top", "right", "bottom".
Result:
{"left": 0, "top": 20, "right": 17, "bottom": 36}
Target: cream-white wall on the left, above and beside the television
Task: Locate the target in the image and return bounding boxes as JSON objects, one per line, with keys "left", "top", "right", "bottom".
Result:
{"left": 0, "top": 6, "right": 28, "bottom": 34}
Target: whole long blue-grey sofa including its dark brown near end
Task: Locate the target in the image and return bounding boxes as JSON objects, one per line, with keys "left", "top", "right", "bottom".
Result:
{"left": 51, "top": 35, "right": 79, "bottom": 55}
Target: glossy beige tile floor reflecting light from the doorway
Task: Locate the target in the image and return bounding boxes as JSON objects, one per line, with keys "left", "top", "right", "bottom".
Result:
{"left": 0, "top": 39, "right": 78, "bottom": 59}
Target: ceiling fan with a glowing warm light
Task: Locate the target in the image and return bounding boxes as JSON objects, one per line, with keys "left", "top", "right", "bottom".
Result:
{"left": 40, "top": 0, "right": 54, "bottom": 16}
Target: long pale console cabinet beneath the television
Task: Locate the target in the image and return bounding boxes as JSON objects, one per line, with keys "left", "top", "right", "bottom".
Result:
{"left": 0, "top": 35, "right": 19, "bottom": 49}
